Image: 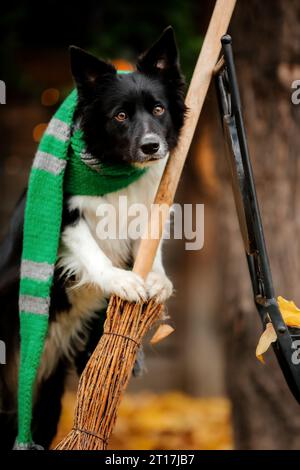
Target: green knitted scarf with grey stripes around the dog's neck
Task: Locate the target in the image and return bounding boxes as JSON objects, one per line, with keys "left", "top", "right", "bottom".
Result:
{"left": 14, "top": 76, "right": 145, "bottom": 449}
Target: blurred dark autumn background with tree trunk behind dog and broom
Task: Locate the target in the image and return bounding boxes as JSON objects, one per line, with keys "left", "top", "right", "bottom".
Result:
{"left": 0, "top": 0, "right": 300, "bottom": 449}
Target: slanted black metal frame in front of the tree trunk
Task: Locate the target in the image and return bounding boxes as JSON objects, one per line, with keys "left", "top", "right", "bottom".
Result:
{"left": 216, "top": 35, "right": 300, "bottom": 403}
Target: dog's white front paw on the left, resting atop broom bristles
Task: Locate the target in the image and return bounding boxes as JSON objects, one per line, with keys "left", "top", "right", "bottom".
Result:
{"left": 103, "top": 268, "right": 147, "bottom": 302}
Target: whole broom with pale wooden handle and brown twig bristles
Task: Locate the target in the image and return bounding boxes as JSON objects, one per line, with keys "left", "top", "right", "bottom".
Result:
{"left": 56, "top": 0, "right": 236, "bottom": 450}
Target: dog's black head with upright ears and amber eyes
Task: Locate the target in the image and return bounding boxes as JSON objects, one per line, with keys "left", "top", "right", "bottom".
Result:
{"left": 70, "top": 27, "right": 185, "bottom": 165}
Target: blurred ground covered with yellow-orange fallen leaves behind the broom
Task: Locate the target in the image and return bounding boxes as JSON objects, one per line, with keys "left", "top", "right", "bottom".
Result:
{"left": 53, "top": 392, "right": 232, "bottom": 450}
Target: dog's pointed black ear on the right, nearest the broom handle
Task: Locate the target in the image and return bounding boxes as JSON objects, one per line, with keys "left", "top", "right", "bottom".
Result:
{"left": 137, "top": 26, "right": 179, "bottom": 74}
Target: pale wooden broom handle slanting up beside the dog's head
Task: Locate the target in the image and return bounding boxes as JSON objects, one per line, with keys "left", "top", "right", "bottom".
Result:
{"left": 133, "top": 0, "right": 236, "bottom": 279}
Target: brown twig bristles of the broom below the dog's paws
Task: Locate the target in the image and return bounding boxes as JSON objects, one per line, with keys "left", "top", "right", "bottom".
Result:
{"left": 55, "top": 296, "right": 163, "bottom": 450}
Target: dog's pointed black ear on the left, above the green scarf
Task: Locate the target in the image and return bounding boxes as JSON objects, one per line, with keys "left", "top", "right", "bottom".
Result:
{"left": 69, "top": 46, "right": 116, "bottom": 89}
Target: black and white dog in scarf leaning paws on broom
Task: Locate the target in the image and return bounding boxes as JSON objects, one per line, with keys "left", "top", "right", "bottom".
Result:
{"left": 0, "top": 27, "right": 185, "bottom": 449}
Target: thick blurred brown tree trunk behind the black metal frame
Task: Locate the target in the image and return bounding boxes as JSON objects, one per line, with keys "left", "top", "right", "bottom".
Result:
{"left": 218, "top": 0, "right": 300, "bottom": 449}
